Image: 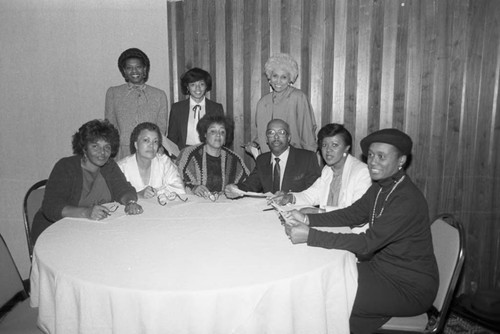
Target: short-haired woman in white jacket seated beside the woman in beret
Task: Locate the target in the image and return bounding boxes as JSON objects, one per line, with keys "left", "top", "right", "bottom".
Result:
{"left": 273, "top": 123, "right": 372, "bottom": 233}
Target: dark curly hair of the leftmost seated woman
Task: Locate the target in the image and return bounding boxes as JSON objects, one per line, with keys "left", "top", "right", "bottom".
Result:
{"left": 72, "top": 119, "right": 120, "bottom": 158}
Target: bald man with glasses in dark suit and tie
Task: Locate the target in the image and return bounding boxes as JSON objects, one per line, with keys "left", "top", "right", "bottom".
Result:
{"left": 225, "top": 119, "right": 321, "bottom": 198}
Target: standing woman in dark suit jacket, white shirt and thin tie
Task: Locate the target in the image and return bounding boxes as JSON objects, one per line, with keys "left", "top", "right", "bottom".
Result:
{"left": 167, "top": 67, "right": 224, "bottom": 150}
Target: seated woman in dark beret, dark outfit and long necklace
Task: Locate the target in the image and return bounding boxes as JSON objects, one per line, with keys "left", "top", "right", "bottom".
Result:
{"left": 285, "top": 129, "right": 439, "bottom": 334}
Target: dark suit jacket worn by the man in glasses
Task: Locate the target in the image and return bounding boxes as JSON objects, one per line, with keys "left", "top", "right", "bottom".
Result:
{"left": 237, "top": 146, "right": 321, "bottom": 193}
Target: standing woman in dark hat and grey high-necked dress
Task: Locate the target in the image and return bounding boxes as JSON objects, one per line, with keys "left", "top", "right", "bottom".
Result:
{"left": 104, "top": 48, "right": 167, "bottom": 161}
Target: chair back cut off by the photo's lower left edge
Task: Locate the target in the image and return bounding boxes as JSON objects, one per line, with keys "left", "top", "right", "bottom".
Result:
{"left": 0, "top": 231, "right": 28, "bottom": 318}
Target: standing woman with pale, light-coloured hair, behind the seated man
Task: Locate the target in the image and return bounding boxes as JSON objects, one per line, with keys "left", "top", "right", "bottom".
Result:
{"left": 246, "top": 53, "right": 317, "bottom": 153}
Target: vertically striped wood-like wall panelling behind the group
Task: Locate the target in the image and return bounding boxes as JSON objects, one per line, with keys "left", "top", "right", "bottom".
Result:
{"left": 167, "top": 0, "right": 500, "bottom": 289}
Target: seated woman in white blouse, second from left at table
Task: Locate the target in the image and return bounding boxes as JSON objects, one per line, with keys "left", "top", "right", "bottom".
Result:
{"left": 118, "top": 122, "right": 186, "bottom": 198}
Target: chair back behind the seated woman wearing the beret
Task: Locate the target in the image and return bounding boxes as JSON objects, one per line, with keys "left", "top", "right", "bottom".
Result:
{"left": 431, "top": 215, "right": 465, "bottom": 333}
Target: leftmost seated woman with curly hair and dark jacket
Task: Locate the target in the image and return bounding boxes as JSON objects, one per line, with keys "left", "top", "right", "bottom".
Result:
{"left": 31, "top": 119, "right": 142, "bottom": 243}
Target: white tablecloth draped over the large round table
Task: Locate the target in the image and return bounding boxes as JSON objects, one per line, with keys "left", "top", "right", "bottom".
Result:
{"left": 31, "top": 196, "right": 357, "bottom": 334}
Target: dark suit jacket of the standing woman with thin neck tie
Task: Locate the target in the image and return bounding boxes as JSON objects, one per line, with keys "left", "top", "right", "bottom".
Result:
{"left": 167, "top": 98, "right": 224, "bottom": 150}
